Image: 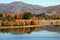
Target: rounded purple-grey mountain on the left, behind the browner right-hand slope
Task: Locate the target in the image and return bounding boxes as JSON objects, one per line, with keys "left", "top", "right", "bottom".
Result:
{"left": 0, "top": 2, "right": 44, "bottom": 13}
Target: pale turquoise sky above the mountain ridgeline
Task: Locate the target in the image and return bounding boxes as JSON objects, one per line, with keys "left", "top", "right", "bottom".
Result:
{"left": 0, "top": 0, "right": 60, "bottom": 7}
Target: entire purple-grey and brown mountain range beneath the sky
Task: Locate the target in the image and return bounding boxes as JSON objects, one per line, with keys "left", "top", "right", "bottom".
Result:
{"left": 0, "top": 2, "right": 60, "bottom": 14}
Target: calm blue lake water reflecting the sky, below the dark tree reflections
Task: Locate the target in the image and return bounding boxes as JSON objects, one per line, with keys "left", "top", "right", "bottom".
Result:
{"left": 0, "top": 30, "right": 60, "bottom": 40}
